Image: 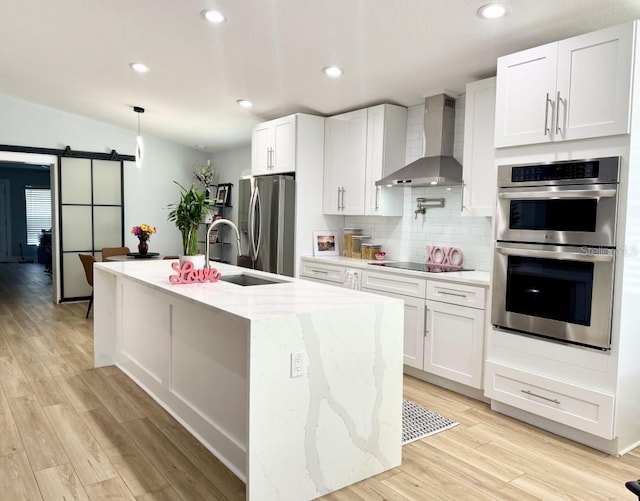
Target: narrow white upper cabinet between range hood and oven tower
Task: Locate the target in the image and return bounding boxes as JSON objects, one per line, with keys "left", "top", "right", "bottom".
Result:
{"left": 462, "top": 77, "right": 496, "bottom": 216}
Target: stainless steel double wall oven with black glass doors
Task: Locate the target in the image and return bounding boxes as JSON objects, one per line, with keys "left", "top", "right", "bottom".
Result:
{"left": 491, "top": 157, "right": 620, "bottom": 350}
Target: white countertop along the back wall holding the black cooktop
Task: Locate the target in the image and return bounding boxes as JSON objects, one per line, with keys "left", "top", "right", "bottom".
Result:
{"left": 301, "top": 256, "right": 491, "bottom": 287}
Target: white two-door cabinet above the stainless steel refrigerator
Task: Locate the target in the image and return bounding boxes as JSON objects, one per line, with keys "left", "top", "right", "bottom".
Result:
{"left": 251, "top": 115, "right": 296, "bottom": 176}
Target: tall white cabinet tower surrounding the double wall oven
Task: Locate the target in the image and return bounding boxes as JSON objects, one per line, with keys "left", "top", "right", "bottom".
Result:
{"left": 484, "top": 21, "right": 640, "bottom": 455}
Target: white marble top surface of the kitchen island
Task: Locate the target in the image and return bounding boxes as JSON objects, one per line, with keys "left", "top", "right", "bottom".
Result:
{"left": 95, "top": 260, "right": 397, "bottom": 320}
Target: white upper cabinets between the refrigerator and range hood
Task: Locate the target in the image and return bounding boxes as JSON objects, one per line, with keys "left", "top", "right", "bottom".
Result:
{"left": 323, "top": 104, "right": 407, "bottom": 216}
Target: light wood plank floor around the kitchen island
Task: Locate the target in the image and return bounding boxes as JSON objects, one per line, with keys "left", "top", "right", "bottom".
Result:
{"left": 0, "top": 264, "right": 640, "bottom": 501}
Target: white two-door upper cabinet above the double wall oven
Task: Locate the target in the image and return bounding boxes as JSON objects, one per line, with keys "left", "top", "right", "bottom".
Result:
{"left": 495, "top": 21, "right": 636, "bottom": 148}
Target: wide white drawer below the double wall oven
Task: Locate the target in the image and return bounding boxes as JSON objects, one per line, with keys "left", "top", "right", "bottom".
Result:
{"left": 485, "top": 362, "right": 615, "bottom": 440}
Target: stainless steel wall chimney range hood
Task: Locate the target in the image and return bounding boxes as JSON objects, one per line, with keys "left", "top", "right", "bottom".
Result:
{"left": 376, "top": 94, "right": 462, "bottom": 187}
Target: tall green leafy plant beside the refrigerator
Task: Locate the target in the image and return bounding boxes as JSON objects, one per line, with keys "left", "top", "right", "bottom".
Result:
{"left": 167, "top": 181, "right": 209, "bottom": 256}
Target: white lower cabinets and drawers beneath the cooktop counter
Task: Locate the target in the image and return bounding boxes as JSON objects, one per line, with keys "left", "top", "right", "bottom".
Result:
{"left": 300, "top": 258, "right": 486, "bottom": 389}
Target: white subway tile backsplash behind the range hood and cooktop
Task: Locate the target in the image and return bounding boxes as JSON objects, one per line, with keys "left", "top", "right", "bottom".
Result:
{"left": 345, "top": 96, "right": 493, "bottom": 271}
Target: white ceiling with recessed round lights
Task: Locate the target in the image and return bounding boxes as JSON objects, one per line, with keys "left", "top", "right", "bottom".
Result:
{"left": 0, "top": 0, "right": 640, "bottom": 151}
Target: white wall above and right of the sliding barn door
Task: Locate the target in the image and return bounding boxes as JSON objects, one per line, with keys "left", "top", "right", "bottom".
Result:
{"left": 0, "top": 95, "right": 209, "bottom": 254}
